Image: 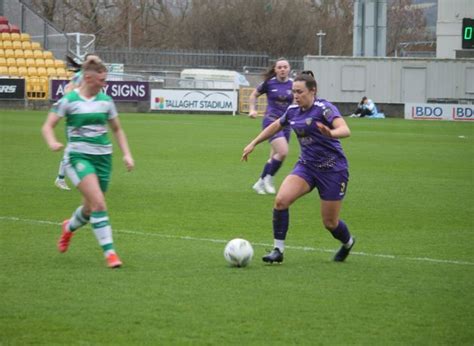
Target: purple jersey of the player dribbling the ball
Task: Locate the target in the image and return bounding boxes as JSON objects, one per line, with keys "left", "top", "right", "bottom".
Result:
{"left": 280, "top": 99, "right": 348, "bottom": 172}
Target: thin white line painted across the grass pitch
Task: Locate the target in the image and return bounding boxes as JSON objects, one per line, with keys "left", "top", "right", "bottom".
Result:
{"left": 0, "top": 216, "right": 474, "bottom": 266}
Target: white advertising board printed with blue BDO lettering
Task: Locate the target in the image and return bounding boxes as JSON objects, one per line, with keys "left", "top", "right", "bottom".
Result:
{"left": 405, "top": 103, "right": 474, "bottom": 120}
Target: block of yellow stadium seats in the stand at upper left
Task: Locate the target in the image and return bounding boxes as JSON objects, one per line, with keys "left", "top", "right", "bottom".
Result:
{"left": 0, "top": 16, "right": 73, "bottom": 99}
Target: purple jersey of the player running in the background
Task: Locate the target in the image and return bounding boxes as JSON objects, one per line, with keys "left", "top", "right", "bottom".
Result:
{"left": 257, "top": 77, "right": 293, "bottom": 121}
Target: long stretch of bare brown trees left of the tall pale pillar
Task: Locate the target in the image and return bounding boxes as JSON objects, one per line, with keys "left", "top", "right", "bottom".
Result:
{"left": 26, "top": 0, "right": 356, "bottom": 57}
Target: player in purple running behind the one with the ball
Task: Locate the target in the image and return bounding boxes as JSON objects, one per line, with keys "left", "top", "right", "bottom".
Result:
{"left": 249, "top": 58, "right": 293, "bottom": 195}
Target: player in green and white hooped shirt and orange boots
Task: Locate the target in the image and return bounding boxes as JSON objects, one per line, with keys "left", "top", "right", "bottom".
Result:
{"left": 42, "top": 61, "right": 134, "bottom": 268}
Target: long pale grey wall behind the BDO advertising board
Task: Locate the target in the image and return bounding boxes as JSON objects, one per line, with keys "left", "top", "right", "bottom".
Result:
{"left": 304, "top": 56, "right": 474, "bottom": 104}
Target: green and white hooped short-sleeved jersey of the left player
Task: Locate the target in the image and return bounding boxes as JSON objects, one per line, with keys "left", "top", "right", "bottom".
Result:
{"left": 55, "top": 89, "right": 118, "bottom": 155}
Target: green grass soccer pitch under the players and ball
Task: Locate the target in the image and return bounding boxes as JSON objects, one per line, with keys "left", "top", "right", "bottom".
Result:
{"left": 0, "top": 110, "right": 474, "bottom": 345}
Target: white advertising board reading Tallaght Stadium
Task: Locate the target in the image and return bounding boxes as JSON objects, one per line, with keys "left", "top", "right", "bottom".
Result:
{"left": 150, "top": 89, "right": 238, "bottom": 114}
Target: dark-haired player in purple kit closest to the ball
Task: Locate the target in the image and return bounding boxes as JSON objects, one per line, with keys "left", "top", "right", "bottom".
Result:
{"left": 242, "top": 74, "right": 355, "bottom": 263}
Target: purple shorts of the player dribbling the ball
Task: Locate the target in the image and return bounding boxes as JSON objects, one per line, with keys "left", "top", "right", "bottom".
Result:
{"left": 291, "top": 162, "right": 349, "bottom": 201}
